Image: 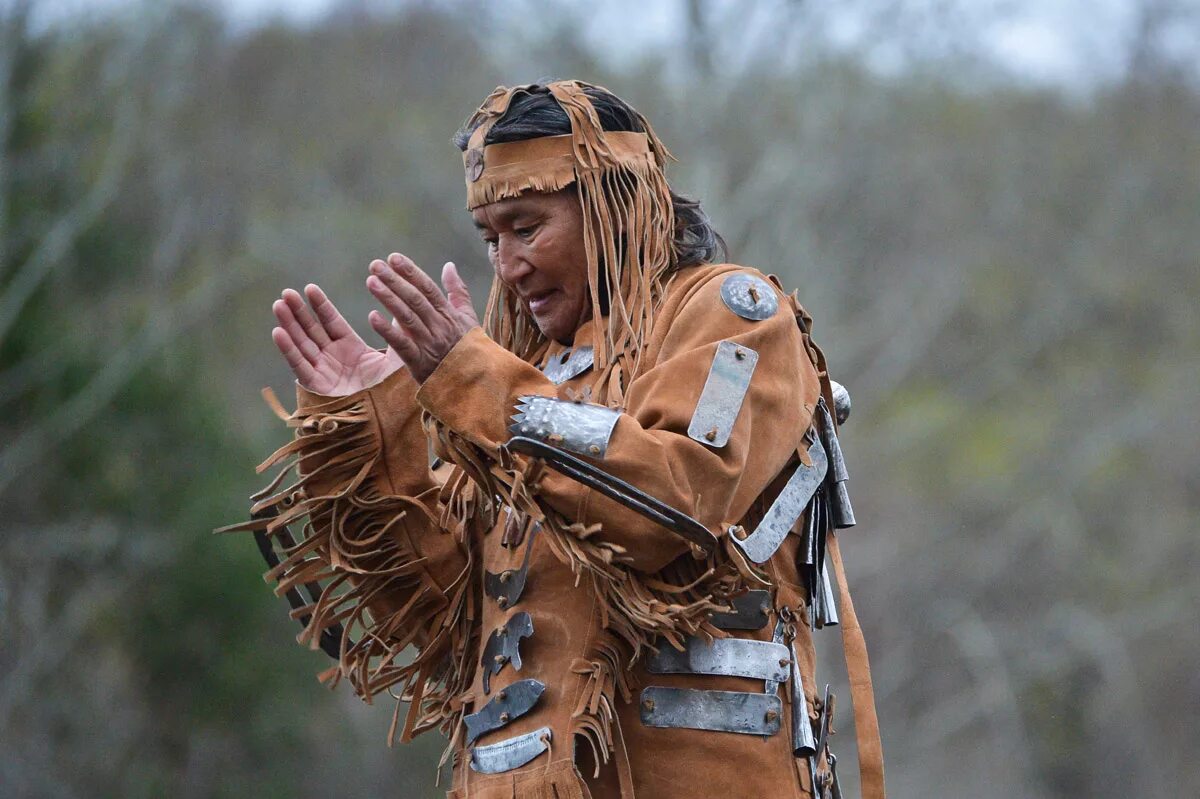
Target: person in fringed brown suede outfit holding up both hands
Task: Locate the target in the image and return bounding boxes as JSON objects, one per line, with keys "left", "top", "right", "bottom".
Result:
{"left": 238, "top": 80, "right": 883, "bottom": 799}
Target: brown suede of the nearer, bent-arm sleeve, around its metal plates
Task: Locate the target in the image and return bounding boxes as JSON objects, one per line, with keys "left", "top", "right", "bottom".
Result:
{"left": 418, "top": 272, "right": 820, "bottom": 571}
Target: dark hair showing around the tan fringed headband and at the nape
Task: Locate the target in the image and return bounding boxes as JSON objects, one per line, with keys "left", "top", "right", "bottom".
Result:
{"left": 452, "top": 84, "right": 728, "bottom": 266}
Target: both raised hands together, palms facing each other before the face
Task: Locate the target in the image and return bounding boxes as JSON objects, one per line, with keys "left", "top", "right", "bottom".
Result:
{"left": 271, "top": 253, "right": 479, "bottom": 396}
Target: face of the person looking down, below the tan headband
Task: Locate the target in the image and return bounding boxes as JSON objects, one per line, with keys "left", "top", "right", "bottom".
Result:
{"left": 470, "top": 186, "right": 592, "bottom": 343}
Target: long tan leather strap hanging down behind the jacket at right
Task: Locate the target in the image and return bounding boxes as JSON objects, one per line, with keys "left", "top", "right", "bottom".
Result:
{"left": 826, "top": 530, "right": 886, "bottom": 799}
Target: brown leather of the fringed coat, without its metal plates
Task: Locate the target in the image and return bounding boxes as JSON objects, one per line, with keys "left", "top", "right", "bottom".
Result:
{"left": 260, "top": 265, "right": 882, "bottom": 799}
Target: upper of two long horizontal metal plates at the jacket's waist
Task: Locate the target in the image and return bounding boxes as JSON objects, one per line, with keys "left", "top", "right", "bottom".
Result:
{"left": 646, "top": 637, "right": 792, "bottom": 683}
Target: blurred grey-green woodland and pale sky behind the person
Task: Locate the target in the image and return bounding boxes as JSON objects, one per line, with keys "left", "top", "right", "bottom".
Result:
{"left": 0, "top": 0, "right": 1200, "bottom": 799}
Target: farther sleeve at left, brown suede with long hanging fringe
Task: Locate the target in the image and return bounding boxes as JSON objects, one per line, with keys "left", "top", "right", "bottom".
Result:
{"left": 231, "top": 370, "right": 472, "bottom": 739}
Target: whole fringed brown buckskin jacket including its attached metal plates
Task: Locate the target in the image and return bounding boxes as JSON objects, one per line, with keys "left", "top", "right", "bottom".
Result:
{"left": 246, "top": 264, "right": 882, "bottom": 799}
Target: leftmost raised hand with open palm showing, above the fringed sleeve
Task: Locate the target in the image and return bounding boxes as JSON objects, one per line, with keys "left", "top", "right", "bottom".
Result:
{"left": 271, "top": 283, "right": 403, "bottom": 397}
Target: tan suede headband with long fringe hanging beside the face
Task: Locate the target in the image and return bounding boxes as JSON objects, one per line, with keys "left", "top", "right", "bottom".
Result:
{"left": 463, "top": 80, "right": 677, "bottom": 404}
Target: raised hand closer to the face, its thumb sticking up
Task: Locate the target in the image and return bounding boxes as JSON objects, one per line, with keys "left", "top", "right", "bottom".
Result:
{"left": 367, "top": 252, "right": 479, "bottom": 383}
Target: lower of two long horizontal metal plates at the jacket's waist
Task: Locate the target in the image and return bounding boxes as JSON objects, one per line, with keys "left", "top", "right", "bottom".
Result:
{"left": 640, "top": 685, "right": 784, "bottom": 735}
